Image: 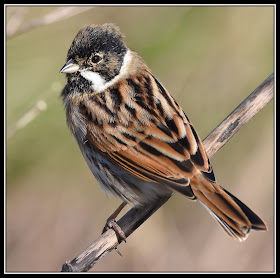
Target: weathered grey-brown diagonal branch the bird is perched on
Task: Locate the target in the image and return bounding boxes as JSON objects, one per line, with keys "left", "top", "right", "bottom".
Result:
{"left": 61, "top": 73, "right": 274, "bottom": 272}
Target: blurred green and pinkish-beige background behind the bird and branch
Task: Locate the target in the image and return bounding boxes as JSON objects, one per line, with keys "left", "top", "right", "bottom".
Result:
{"left": 6, "top": 6, "right": 274, "bottom": 271}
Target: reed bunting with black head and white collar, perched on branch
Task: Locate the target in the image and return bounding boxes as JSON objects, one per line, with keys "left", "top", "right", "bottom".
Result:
{"left": 60, "top": 24, "right": 267, "bottom": 241}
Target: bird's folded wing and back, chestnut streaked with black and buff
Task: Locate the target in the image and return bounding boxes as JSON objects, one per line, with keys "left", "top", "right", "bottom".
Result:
{"left": 79, "top": 72, "right": 215, "bottom": 197}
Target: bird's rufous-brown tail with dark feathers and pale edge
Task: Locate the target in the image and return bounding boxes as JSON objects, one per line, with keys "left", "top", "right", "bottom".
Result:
{"left": 190, "top": 174, "right": 267, "bottom": 241}
